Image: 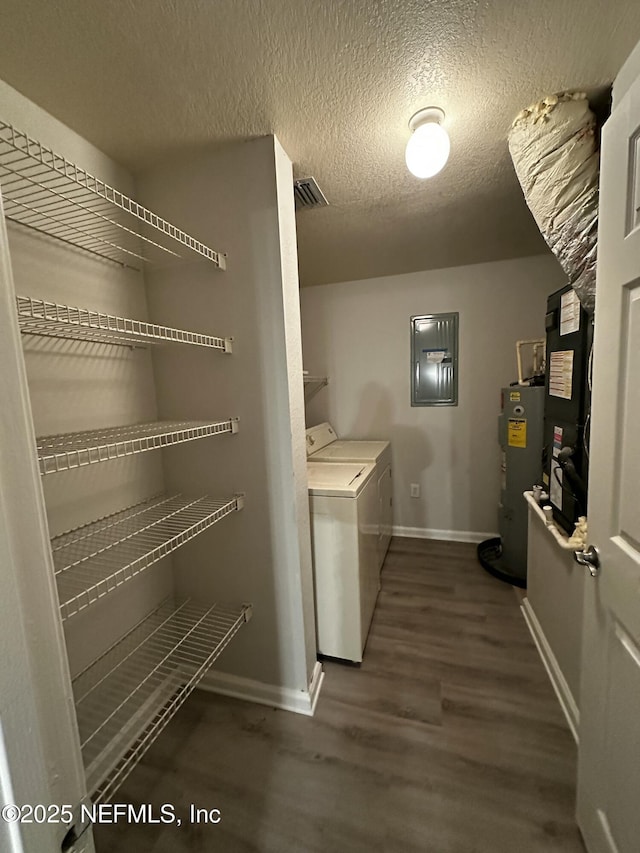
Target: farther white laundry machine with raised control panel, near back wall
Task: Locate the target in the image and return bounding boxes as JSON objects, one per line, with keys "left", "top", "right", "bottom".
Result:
{"left": 307, "top": 423, "right": 393, "bottom": 568}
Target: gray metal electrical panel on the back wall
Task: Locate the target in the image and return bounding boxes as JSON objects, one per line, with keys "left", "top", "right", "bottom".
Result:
{"left": 411, "top": 311, "right": 458, "bottom": 406}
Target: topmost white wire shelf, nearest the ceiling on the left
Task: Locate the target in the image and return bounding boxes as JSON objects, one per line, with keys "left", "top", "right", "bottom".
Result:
{"left": 0, "top": 121, "right": 225, "bottom": 269}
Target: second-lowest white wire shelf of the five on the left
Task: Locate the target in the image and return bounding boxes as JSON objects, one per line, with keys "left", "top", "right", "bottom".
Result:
{"left": 51, "top": 495, "right": 243, "bottom": 621}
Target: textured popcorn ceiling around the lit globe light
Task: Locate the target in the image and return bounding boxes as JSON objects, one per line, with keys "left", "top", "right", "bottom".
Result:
{"left": 0, "top": 0, "right": 640, "bottom": 285}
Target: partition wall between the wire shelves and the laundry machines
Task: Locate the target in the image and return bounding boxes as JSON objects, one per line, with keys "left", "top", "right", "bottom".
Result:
{"left": 138, "top": 137, "right": 319, "bottom": 710}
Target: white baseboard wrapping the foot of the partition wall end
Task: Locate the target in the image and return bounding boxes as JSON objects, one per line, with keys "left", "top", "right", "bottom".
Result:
{"left": 198, "top": 661, "right": 324, "bottom": 717}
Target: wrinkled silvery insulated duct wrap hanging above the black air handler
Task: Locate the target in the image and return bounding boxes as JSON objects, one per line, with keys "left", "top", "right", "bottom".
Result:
{"left": 509, "top": 92, "right": 599, "bottom": 313}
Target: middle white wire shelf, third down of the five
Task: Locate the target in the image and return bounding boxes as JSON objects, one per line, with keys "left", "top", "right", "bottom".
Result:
{"left": 36, "top": 418, "right": 238, "bottom": 474}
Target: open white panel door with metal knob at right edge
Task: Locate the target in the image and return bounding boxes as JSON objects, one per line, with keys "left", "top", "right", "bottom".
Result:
{"left": 578, "top": 48, "right": 640, "bottom": 853}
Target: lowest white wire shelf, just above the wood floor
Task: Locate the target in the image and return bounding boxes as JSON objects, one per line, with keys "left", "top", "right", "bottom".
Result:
{"left": 73, "top": 600, "right": 251, "bottom": 803}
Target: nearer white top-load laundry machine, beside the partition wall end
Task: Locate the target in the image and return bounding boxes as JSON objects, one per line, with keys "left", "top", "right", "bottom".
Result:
{"left": 307, "top": 462, "right": 380, "bottom": 663}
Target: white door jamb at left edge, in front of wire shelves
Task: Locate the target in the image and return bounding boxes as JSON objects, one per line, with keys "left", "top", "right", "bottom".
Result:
{"left": 0, "top": 200, "right": 93, "bottom": 853}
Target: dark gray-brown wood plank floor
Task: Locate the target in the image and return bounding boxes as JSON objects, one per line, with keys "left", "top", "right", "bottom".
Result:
{"left": 95, "top": 538, "right": 584, "bottom": 853}
